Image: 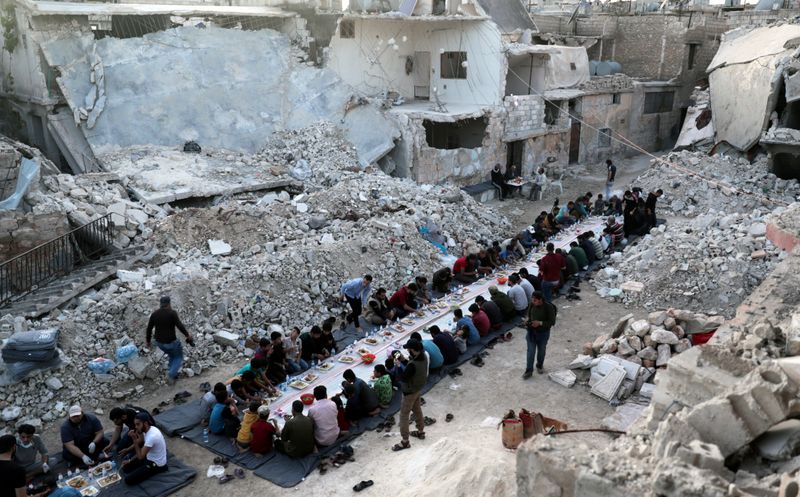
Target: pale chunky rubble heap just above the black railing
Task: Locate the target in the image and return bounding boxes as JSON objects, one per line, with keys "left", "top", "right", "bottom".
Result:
{"left": 25, "top": 173, "right": 167, "bottom": 248}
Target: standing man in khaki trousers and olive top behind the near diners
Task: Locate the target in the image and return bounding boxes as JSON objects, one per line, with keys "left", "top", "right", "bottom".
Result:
{"left": 392, "top": 338, "right": 428, "bottom": 452}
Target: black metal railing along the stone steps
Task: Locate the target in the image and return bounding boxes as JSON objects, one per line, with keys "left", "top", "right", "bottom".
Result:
{"left": 0, "top": 214, "right": 114, "bottom": 305}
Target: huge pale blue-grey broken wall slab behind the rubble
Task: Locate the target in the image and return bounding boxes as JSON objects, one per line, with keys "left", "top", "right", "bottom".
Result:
{"left": 43, "top": 27, "right": 397, "bottom": 163}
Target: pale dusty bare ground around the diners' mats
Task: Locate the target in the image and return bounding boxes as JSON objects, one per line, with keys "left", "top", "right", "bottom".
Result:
{"left": 36, "top": 153, "right": 664, "bottom": 497}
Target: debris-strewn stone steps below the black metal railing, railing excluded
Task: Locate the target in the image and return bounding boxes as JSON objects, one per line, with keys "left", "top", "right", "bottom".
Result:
{"left": 0, "top": 246, "right": 147, "bottom": 318}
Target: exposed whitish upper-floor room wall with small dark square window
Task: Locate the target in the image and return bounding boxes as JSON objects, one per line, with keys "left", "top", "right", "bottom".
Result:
{"left": 326, "top": 18, "right": 506, "bottom": 105}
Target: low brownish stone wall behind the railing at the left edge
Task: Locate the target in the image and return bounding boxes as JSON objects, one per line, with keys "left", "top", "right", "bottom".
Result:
{"left": 0, "top": 211, "right": 69, "bottom": 261}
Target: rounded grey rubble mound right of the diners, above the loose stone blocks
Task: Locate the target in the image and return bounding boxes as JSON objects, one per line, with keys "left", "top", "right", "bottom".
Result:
{"left": 593, "top": 209, "right": 786, "bottom": 317}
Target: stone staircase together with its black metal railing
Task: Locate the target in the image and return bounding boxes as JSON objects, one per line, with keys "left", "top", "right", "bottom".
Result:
{"left": 0, "top": 215, "right": 146, "bottom": 318}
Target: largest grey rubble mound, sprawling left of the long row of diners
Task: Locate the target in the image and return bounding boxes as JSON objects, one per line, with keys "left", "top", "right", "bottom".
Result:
{"left": 0, "top": 127, "right": 511, "bottom": 430}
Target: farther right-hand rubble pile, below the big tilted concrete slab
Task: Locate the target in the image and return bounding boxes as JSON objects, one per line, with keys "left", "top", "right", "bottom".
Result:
{"left": 633, "top": 150, "right": 800, "bottom": 217}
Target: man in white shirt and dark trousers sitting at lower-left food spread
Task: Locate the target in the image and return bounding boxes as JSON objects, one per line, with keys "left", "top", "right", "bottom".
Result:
{"left": 122, "top": 412, "right": 168, "bottom": 485}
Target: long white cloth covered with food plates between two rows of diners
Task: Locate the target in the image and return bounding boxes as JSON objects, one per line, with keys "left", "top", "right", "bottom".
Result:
{"left": 270, "top": 217, "right": 604, "bottom": 426}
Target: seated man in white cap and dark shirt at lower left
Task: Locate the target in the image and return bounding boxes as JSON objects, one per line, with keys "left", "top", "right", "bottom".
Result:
{"left": 61, "top": 405, "right": 108, "bottom": 466}
